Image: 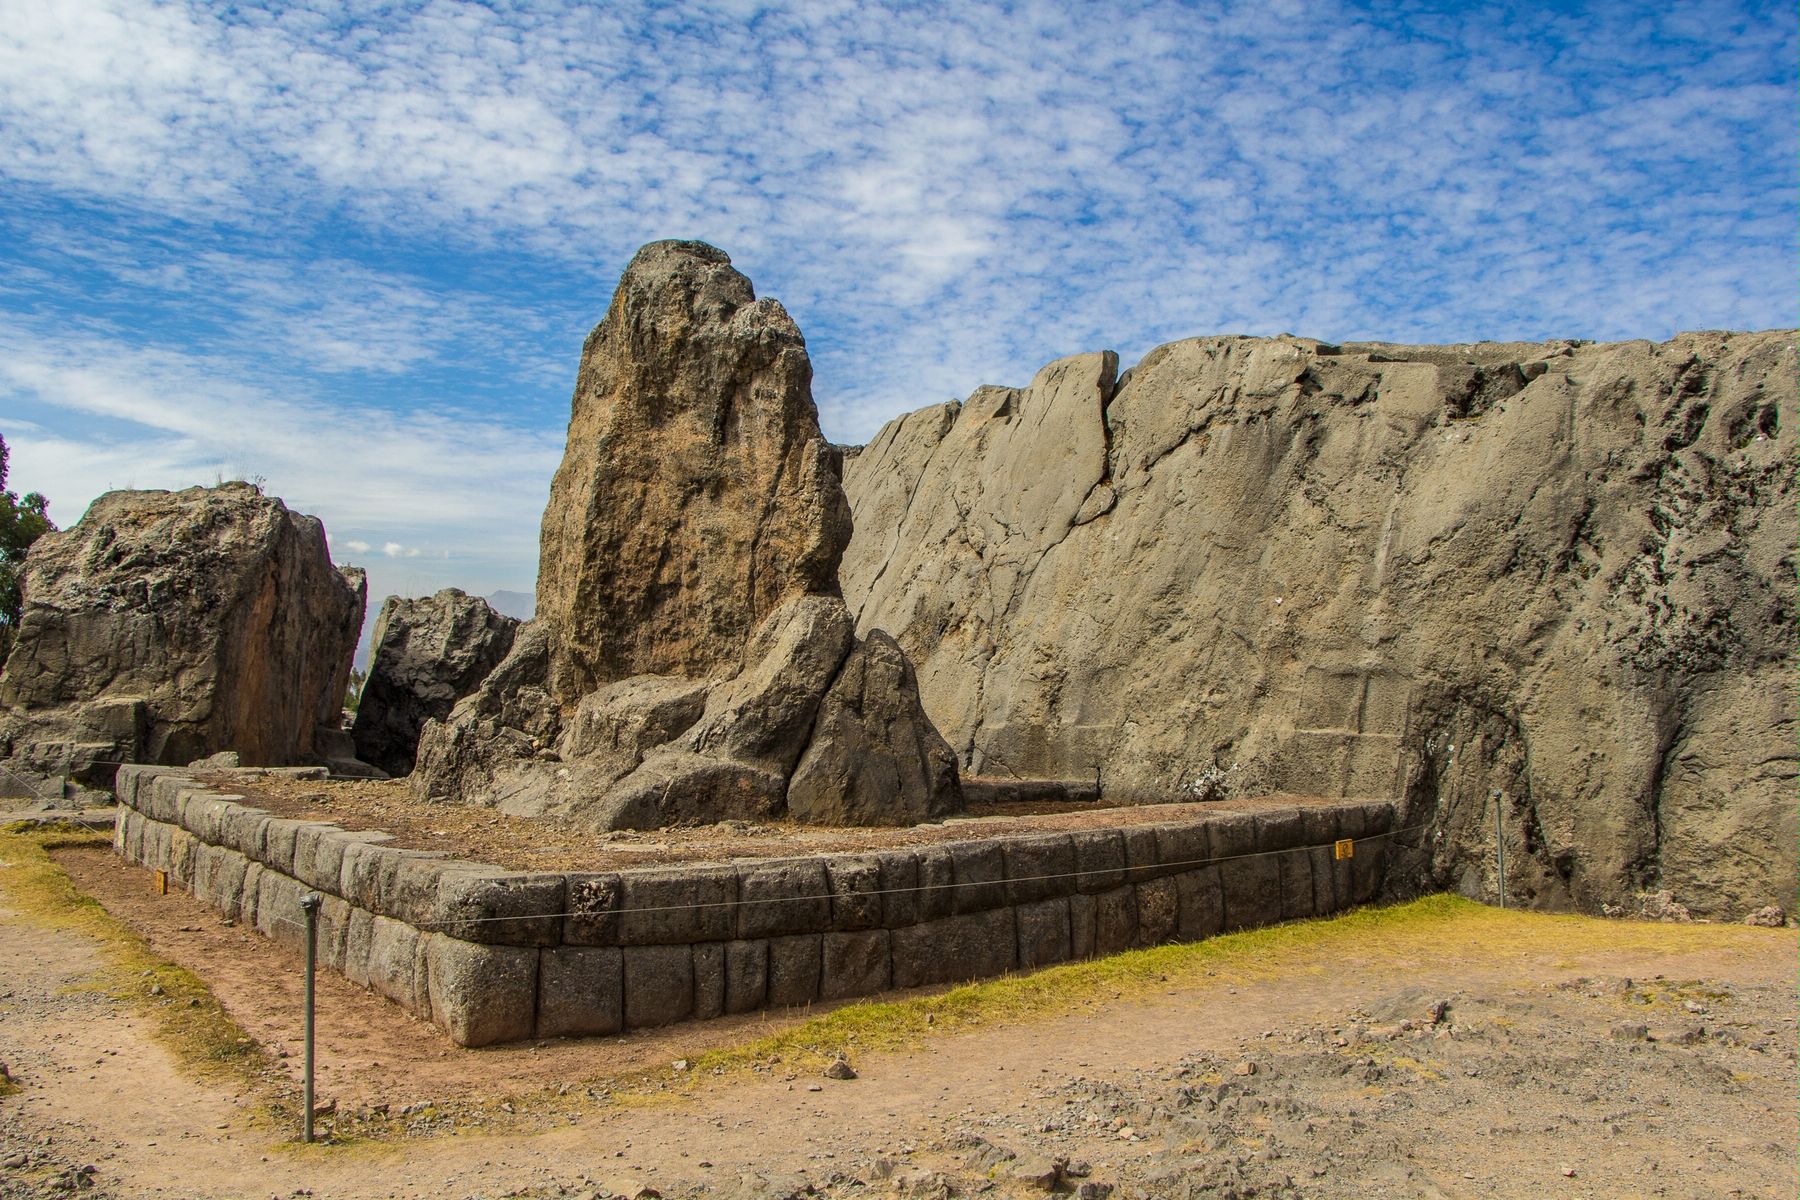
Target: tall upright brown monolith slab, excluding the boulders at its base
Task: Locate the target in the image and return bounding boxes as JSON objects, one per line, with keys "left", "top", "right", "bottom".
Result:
{"left": 538, "top": 241, "right": 850, "bottom": 703}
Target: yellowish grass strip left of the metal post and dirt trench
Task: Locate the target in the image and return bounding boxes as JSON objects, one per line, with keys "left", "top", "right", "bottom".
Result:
{"left": 0, "top": 826, "right": 275, "bottom": 1101}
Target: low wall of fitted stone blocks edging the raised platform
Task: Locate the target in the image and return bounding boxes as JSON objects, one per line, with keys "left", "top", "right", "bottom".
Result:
{"left": 115, "top": 766, "right": 1393, "bottom": 1045}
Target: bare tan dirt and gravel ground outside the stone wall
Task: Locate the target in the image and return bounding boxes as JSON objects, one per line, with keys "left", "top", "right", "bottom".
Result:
{"left": 0, "top": 851, "right": 1800, "bottom": 1200}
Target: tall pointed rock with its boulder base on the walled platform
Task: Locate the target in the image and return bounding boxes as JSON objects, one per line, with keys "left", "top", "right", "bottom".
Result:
{"left": 414, "top": 241, "right": 959, "bottom": 829}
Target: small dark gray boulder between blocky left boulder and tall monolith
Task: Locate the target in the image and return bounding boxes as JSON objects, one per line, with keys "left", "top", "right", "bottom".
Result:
{"left": 351, "top": 588, "right": 518, "bottom": 775}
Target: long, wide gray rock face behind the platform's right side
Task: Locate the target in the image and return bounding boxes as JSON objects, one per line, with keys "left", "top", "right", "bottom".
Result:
{"left": 842, "top": 333, "right": 1800, "bottom": 914}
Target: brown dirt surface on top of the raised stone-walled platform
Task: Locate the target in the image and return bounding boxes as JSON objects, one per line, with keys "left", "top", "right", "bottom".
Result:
{"left": 202, "top": 772, "right": 1353, "bottom": 871}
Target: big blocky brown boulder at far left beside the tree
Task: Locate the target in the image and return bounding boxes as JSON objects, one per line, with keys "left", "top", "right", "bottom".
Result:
{"left": 0, "top": 482, "right": 364, "bottom": 783}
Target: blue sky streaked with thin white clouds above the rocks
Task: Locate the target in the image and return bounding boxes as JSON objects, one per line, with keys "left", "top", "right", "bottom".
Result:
{"left": 0, "top": 0, "right": 1800, "bottom": 615}
